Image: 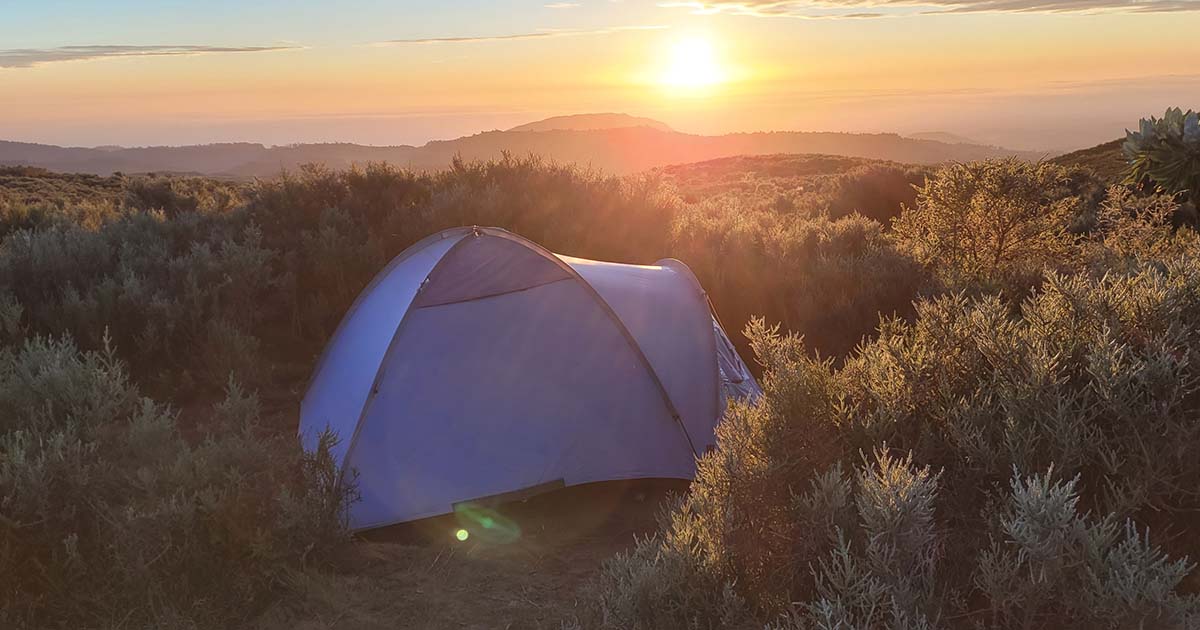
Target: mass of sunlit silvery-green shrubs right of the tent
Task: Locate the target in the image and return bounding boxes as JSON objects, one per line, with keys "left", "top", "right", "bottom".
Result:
{"left": 580, "top": 162, "right": 1200, "bottom": 630}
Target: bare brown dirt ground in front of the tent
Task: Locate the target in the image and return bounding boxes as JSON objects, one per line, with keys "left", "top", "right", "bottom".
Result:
{"left": 251, "top": 480, "right": 686, "bottom": 630}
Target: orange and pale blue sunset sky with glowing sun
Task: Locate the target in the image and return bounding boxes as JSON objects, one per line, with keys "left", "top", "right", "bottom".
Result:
{"left": 0, "top": 0, "right": 1200, "bottom": 150}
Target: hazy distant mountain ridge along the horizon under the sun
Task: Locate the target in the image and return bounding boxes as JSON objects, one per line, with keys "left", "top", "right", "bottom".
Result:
{"left": 0, "top": 116, "right": 1048, "bottom": 178}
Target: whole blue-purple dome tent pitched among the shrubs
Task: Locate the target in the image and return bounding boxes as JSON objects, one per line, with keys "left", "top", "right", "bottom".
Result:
{"left": 300, "top": 228, "right": 758, "bottom": 529}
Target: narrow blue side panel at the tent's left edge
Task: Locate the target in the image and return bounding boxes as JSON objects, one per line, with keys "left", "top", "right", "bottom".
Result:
{"left": 300, "top": 234, "right": 462, "bottom": 462}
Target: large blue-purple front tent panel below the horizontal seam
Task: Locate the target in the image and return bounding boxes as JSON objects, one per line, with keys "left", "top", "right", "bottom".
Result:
{"left": 348, "top": 281, "right": 695, "bottom": 529}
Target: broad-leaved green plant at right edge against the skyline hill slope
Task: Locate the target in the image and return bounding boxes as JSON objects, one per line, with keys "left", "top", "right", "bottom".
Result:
{"left": 1122, "top": 107, "right": 1200, "bottom": 203}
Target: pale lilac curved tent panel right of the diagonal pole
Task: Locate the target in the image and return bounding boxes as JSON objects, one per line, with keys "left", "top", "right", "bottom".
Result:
{"left": 560, "top": 256, "right": 720, "bottom": 452}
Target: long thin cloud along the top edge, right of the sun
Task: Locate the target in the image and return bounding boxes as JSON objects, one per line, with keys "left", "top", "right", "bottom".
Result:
{"left": 660, "top": 0, "right": 1200, "bottom": 19}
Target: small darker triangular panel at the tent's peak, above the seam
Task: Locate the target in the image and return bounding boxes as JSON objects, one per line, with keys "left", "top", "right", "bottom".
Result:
{"left": 413, "top": 232, "right": 570, "bottom": 308}
